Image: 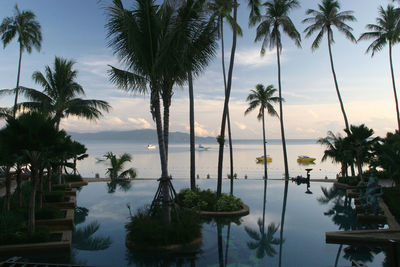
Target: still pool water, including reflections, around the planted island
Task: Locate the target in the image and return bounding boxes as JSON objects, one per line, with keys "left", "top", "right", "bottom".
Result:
{"left": 30, "top": 179, "right": 385, "bottom": 267}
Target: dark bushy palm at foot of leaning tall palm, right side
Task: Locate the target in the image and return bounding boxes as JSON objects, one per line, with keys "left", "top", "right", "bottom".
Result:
{"left": 346, "top": 124, "right": 378, "bottom": 180}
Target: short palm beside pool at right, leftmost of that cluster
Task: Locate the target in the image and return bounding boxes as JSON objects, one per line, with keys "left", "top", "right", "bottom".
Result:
{"left": 317, "top": 131, "right": 353, "bottom": 177}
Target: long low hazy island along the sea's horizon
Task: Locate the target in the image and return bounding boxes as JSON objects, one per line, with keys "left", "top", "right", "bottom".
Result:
{"left": 68, "top": 129, "right": 316, "bottom": 145}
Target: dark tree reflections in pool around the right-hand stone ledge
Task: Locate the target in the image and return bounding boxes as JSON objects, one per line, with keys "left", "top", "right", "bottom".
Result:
{"left": 317, "top": 186, "right": 382, "bottom": 266}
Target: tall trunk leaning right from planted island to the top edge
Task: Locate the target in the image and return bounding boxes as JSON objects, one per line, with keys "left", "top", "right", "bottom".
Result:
{"left": 217, "top": 0, "right": 237, "bottom": 198}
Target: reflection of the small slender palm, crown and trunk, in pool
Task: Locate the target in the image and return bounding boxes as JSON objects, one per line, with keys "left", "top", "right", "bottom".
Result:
{"left": 244, "top": 179, "right": 283, "bottom": 259}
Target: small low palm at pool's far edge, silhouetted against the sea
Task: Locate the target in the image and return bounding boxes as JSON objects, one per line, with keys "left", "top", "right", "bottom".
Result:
{"left": 98, "top": 152, "right": 136, "bottom": 179}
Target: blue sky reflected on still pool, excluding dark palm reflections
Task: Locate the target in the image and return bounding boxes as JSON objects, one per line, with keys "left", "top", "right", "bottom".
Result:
{"left": 49, "top": 180, "right": 384, "bottom": 267}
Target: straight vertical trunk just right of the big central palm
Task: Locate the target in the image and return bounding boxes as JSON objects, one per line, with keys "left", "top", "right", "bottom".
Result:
{"left": 188, "top": 71, "right": 196, "bottom": 191}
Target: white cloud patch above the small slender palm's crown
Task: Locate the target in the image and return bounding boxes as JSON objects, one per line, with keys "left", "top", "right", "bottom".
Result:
{"left": 235, "top": 48, "right": 276, "bottom": 68}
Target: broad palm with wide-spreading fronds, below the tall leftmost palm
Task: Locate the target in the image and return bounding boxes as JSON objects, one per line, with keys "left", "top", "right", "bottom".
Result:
{"left": 15, "top": 57, "right": 111, "bottom": 129}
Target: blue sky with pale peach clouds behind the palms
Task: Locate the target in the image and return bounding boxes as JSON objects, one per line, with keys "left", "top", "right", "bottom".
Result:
{"left": 0, "top": 0, "right": 400, "bottom": 139}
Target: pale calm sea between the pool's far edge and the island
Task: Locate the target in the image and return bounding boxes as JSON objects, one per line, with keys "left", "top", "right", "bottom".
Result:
{"left": 78, "top": 139, "right": 340, "bottom": 179}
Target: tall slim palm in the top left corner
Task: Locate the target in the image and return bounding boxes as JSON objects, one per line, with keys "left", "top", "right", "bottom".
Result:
{"left": 0, "top": 5, "right": 42, "bottom": 118}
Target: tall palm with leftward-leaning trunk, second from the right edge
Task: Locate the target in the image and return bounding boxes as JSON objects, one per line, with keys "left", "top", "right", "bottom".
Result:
{"left": 303, "top": 0, "right": 356, "bottom": 133}
